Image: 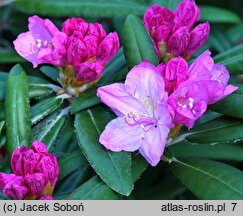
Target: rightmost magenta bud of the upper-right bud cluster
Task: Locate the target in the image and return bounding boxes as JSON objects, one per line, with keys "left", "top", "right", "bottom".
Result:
{"left": 186, "top": 23, "right": 210, "bottom": 56}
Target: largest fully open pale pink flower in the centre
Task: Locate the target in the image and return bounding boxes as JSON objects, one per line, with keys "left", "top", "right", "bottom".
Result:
{"left": 97, "top": 62, "right": 173, "bottom": 166}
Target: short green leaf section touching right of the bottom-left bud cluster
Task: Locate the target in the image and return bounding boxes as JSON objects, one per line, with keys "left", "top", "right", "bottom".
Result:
{"left": 58, "top": 151, "right": 89, "bottom": 180}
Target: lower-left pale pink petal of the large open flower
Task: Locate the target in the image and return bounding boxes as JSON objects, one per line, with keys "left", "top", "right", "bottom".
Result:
{"left": 99, "top": 117, "right": 144, "bottom": 152}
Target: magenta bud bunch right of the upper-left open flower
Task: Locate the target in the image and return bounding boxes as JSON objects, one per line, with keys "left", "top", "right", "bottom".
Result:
{"left": 62, "top": 18, "right": 120, "bottom": 83}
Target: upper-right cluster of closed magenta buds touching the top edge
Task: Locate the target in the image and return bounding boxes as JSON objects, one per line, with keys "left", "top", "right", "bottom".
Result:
{"left": 144, "top": 0, "right": 210, "bottom": 61}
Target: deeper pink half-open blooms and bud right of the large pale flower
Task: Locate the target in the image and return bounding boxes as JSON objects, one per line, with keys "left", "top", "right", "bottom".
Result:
{"left": 157, "top": 50, "right": 237, "bottom": 129}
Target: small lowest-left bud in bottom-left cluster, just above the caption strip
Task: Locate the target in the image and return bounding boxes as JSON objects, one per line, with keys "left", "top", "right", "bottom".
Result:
{"left": 3, "top": 176, "right": 29, "bottom": 200}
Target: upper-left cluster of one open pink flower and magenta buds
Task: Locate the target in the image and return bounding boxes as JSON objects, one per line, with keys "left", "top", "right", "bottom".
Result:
{"left": 14, "top": 16, "right": 120, "bottom": 83}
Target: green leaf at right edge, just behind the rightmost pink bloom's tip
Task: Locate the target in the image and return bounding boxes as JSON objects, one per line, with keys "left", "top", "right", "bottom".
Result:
{"left": 214, "top": 44, "right": 243, "bottom": 75}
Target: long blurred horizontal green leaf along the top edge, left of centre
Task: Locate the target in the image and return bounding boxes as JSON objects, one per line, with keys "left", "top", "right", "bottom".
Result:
{"left": 15, "top": 0, "right": 146, "bottom": 17}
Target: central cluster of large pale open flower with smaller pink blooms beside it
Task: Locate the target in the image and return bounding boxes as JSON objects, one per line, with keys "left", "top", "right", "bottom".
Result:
{"left": 97, "top": 51, "right": 237, "bottom": 166}
